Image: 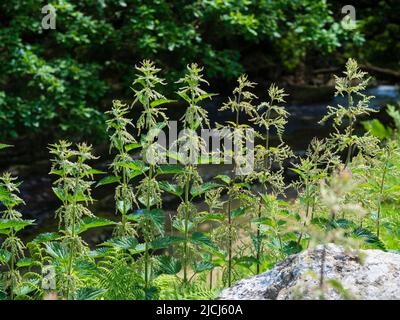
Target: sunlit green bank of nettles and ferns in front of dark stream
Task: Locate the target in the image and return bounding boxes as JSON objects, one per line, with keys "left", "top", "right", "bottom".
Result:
{"left": 0, "top": 59, "right": 400, "bottom": 300}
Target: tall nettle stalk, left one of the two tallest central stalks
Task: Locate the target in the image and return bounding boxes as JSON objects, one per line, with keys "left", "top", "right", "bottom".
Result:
{"left": 132, "top": 60, "right": 172, "bottom": 292}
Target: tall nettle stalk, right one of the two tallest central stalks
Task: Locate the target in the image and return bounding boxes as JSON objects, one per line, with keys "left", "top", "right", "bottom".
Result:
{"left": 174, "top": 63, "right": 213, "bottom": 284}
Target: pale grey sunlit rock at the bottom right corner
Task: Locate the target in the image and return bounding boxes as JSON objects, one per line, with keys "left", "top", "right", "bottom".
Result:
{"left": 218, "top": 244, "right": 400, "bottom": 300}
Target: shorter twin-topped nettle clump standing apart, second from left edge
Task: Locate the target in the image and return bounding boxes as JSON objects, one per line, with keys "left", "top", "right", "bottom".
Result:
{"left": 49, "top": 141, "right": 95, "bottom": 299}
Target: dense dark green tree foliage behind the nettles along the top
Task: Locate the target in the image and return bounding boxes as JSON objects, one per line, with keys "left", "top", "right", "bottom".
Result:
{"left": 0, "top": 0, "right": 399, "bottom": 140}
